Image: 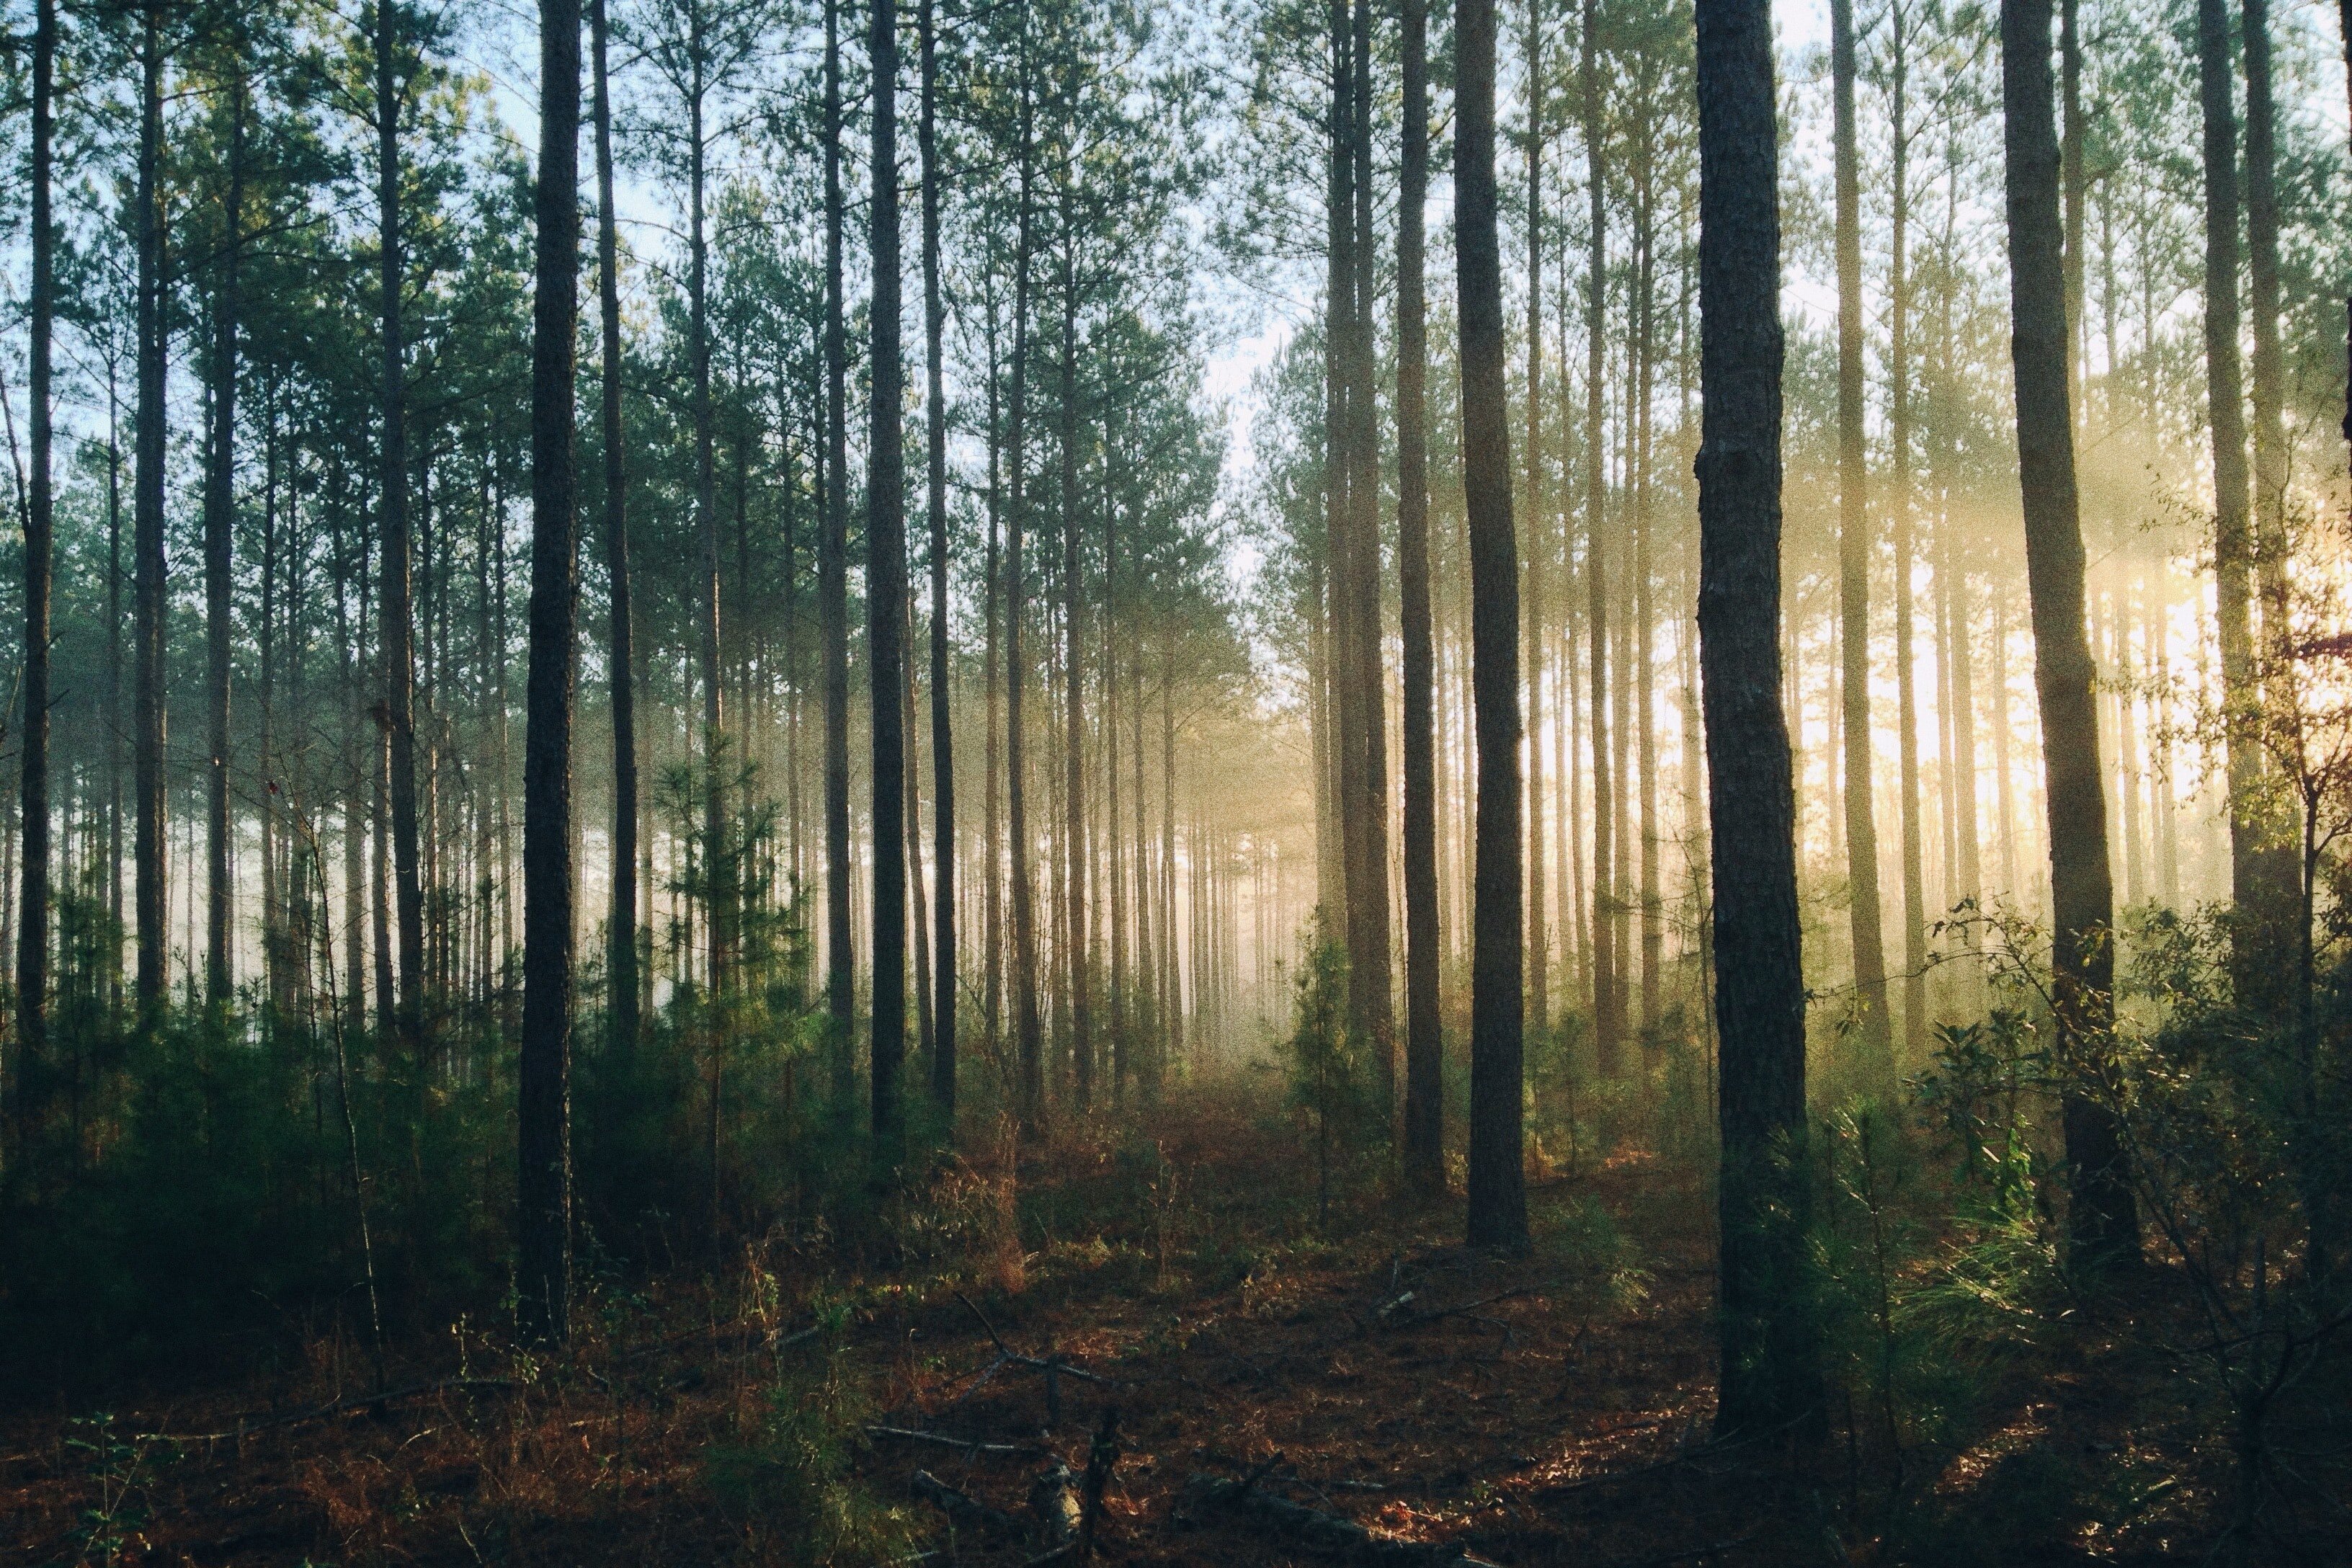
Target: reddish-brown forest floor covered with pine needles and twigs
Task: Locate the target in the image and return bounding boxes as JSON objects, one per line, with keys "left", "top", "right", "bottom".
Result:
{"left": 0, "top": 1095, "right": 2276, "bottom": 1568}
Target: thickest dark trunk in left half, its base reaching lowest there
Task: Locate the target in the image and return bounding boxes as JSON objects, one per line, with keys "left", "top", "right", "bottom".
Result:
{"left": 515, "top": 0, "right": 578, "bottom": 1342}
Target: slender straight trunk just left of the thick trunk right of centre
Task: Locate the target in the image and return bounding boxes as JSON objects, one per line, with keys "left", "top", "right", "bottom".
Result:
{"left": 1392, "top": 0, "right": 1430, "bottom": 1192}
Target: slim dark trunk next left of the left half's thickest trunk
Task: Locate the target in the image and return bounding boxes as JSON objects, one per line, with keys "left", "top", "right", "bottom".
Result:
{"left": 376, "top": 0, "right": 428, "bottom": 1067}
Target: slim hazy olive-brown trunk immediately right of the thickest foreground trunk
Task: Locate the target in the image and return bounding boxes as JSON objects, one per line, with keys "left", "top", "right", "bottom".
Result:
{"left": 1830, "top": 0, "right": 1907, "bottom": 1084}
